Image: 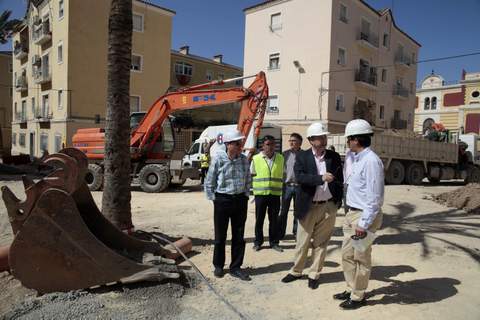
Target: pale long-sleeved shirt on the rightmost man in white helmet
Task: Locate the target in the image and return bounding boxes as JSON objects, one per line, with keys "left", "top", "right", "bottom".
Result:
{"left": 346, "top": 148, "right": 385, "bottom": 229}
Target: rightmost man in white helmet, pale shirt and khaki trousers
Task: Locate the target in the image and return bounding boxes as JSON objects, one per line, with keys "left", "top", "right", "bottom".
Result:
{"left": 333, "top": 119, "right": 384, "bottom": 309}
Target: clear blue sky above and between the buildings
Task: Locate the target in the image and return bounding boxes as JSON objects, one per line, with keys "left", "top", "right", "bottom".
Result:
{"left": 0, "top": 0, "right": 480, "bottom": 81}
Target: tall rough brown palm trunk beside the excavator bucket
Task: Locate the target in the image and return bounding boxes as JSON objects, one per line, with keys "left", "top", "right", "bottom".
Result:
{"left": 102, "top": 0, "right": 133, "bottom": 229}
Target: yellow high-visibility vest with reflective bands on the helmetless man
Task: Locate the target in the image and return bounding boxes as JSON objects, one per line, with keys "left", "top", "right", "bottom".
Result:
{"left": 252, "top": 153, "right": 285, "bottom": 196}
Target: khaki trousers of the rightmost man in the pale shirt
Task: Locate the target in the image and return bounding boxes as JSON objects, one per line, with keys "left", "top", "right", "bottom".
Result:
{"left": 342, "top": 209, "right": 383, "bottom": 301}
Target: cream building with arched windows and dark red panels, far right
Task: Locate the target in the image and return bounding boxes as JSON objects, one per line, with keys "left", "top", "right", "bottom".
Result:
{"left": 415, "top": 70, "right": 480, "bottom": 139}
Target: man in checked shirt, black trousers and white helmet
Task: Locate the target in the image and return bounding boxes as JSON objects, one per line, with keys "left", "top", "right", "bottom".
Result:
{"left": 205, "top": 129, "right": 252, "bottom": 281}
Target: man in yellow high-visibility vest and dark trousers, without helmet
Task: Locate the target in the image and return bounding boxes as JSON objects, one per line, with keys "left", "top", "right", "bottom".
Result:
{"left": 250, "top": 135, "right": 284, "bottom": 252}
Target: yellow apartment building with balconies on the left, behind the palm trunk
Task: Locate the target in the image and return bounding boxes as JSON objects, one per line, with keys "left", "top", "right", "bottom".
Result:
{"left": 12, "top": 0, "right": 175, "bottom": 156}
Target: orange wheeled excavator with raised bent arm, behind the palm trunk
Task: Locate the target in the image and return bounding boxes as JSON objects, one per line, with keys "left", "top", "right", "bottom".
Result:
{"left": 72, "top": 72, "right": 268, "bottom": 192}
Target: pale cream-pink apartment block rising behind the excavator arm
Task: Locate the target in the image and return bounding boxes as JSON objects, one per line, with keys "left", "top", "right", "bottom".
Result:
{"left": 244, "top": 0, "right": 420, "bottom": 147}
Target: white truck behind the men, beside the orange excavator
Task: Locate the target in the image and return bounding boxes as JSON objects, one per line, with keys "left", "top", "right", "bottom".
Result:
{"left": 182, "top": 123, "right": 282, "bottom": 180}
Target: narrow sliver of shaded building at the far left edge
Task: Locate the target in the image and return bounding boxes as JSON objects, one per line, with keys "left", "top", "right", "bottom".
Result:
{"left": 0, "top": 51, "right": 13, "bottom": 154}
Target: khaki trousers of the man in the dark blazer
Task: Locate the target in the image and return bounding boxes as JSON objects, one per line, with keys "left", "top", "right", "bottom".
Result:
{"left": 290, "top": 201, "right": 337, "bottom": 280}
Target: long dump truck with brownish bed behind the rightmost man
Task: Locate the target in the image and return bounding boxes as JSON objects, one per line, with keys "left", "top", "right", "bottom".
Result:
{"left": 328, "top": 134, "right": 480, "bottom": 185}
